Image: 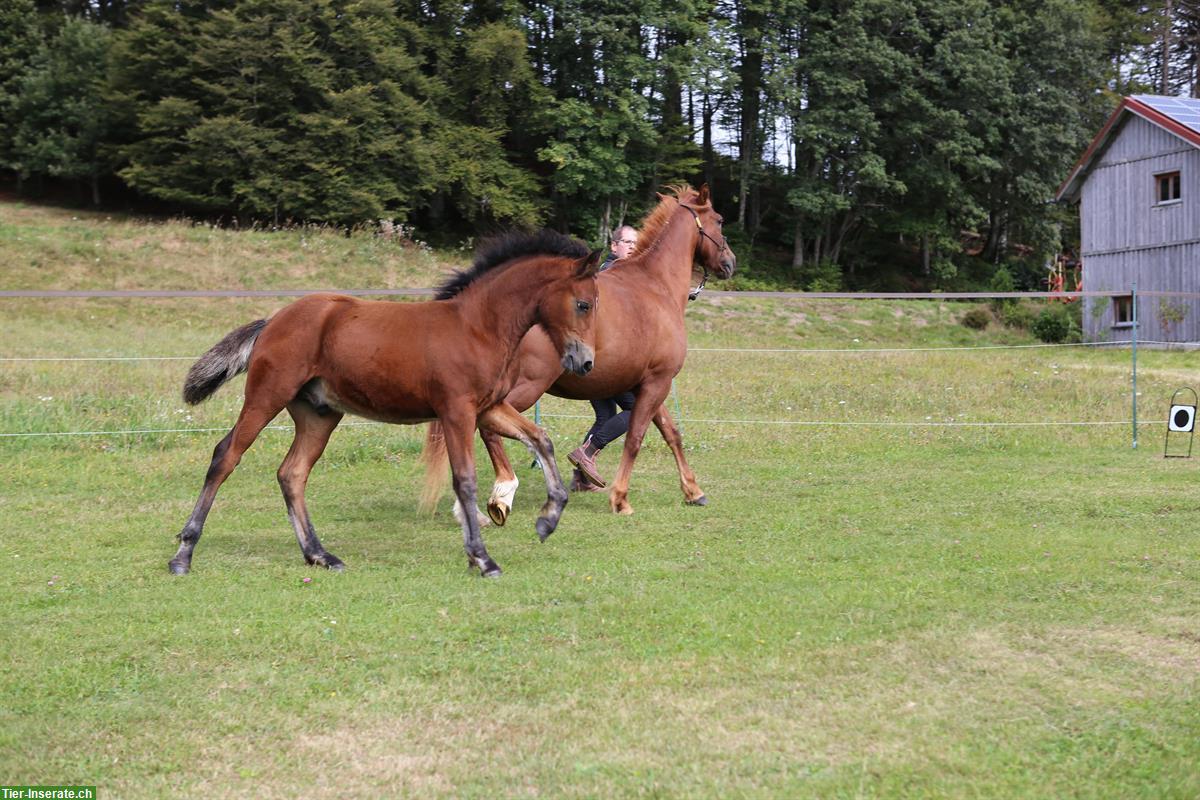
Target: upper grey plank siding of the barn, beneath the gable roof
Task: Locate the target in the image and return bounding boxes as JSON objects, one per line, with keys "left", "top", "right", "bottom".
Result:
{"left": 1080, "top": 116, "right": 1200, "bottom": 253}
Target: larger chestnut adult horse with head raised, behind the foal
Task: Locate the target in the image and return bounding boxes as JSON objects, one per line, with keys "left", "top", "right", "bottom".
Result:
{"left": 425, "top": 186, "right": 737, "bottom": 525}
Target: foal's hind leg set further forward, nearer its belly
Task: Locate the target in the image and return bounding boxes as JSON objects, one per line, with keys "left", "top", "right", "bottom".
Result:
{"left": 278, "top": 399, "right": 346, "bottom": 570}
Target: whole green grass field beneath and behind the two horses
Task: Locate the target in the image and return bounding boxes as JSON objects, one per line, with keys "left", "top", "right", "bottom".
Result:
{"left": 0, "top": 204, "right": 1200, "bottom": 798}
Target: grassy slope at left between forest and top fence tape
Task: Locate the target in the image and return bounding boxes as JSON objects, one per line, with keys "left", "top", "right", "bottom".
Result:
{"left": 0, "top": 203, "right": 460, "bottom": 289}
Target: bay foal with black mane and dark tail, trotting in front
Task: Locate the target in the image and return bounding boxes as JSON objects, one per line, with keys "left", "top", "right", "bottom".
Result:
{"left": 169, "top": 231, "right": 598, "bottom": 577}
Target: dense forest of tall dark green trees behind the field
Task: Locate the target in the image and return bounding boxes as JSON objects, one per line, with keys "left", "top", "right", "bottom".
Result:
{"left": 0, "top": 0, "right": 1200, "bottom": 289}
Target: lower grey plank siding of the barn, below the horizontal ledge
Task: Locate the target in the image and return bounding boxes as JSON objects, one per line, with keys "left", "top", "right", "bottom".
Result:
{"left": 1084, "top": 243, "right": 1200, "bottom": 342}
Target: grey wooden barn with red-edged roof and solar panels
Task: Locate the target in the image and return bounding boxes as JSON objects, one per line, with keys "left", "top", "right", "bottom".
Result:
{"left": 1058, "top": 95, "right": 1200, "bottom": 342}
